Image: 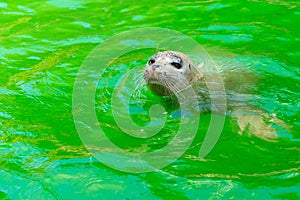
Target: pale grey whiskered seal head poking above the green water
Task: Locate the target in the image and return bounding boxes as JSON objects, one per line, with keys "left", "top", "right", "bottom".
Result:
{"left": 143, "top": 51, "right": 203, "bottom": 96}
